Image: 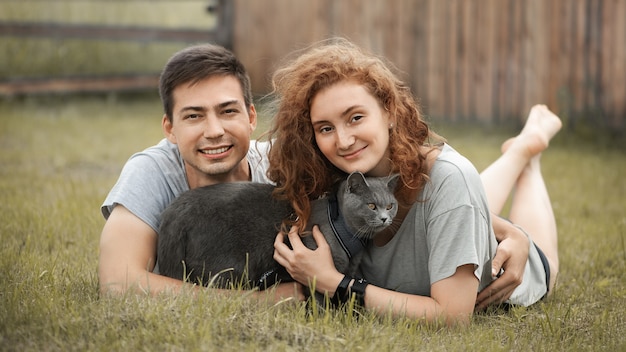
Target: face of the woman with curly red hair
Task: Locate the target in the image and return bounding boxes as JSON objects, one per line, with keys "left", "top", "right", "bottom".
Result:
{"left": 311, "top": 81, "right": 391, "bottom": 177}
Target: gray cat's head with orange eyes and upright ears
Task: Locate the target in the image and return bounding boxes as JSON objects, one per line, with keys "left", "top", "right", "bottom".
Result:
{"left": 337, "top": 171, "right": 399, "bottom": 239}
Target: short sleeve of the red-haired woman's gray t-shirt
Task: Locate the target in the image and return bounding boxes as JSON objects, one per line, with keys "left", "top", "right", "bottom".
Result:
{"left": 426, "top": 160, "right": 490, "bottom": 284}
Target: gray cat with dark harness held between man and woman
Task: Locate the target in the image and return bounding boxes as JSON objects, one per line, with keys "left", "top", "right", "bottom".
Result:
{"left": 158, "top": 172, "right": 398, "bottom": 289}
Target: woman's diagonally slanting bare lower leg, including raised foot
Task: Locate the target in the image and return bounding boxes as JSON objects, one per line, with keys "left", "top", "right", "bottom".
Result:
{"left": 480, "top": 105, "right": 561, "bottom": 214}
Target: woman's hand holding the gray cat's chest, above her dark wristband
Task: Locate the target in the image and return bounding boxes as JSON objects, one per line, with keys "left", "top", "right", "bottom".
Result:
{"left": 274, "top": 226, "right": 343, "bottom": 296}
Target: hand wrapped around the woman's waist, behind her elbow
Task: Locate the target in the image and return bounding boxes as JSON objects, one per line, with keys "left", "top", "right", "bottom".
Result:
{"left": 476, "top": 216, "right": 530, "bottom": 310}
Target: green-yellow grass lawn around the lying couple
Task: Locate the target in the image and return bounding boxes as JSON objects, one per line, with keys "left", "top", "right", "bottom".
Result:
{"left": 0, "top": 97, "right": 626, "bottom": 351}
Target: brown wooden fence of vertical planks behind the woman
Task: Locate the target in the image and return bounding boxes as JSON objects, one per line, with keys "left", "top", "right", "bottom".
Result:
{"left": 233, "top": 0, "right": 626, "bottom": 131}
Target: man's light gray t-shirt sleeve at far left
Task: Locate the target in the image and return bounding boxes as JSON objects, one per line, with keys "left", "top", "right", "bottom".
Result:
{"left": 101, "top": 153, "right": 186, "bottom": 231}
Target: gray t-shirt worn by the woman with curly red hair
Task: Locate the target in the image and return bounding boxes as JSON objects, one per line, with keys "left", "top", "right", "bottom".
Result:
{"left": 360, "top": 144, "right": 546, "bottom": 305}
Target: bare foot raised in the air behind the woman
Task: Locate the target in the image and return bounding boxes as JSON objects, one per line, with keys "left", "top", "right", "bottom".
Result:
{"left": 501, "top": 105, "right": 563, "bottom": 158}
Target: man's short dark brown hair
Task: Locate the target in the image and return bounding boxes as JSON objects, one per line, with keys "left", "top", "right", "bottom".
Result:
{"left": 159, "top": 44, "right": 252, "bottom": 121}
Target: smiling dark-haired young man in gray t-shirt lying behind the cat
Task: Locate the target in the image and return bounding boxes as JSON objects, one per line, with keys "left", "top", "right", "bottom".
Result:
{"left": 98, "top": 45, "right": 303, "bottom": 299}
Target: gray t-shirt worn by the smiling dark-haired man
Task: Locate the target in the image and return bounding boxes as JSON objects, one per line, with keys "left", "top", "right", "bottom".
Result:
{"left": 101, "top": 139, "right": 271, "bottom": 231}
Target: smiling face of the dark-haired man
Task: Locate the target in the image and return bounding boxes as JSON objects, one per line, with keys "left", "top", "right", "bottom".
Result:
{"left": 163, "top": 76, "right": 256, "bottom": 188}
